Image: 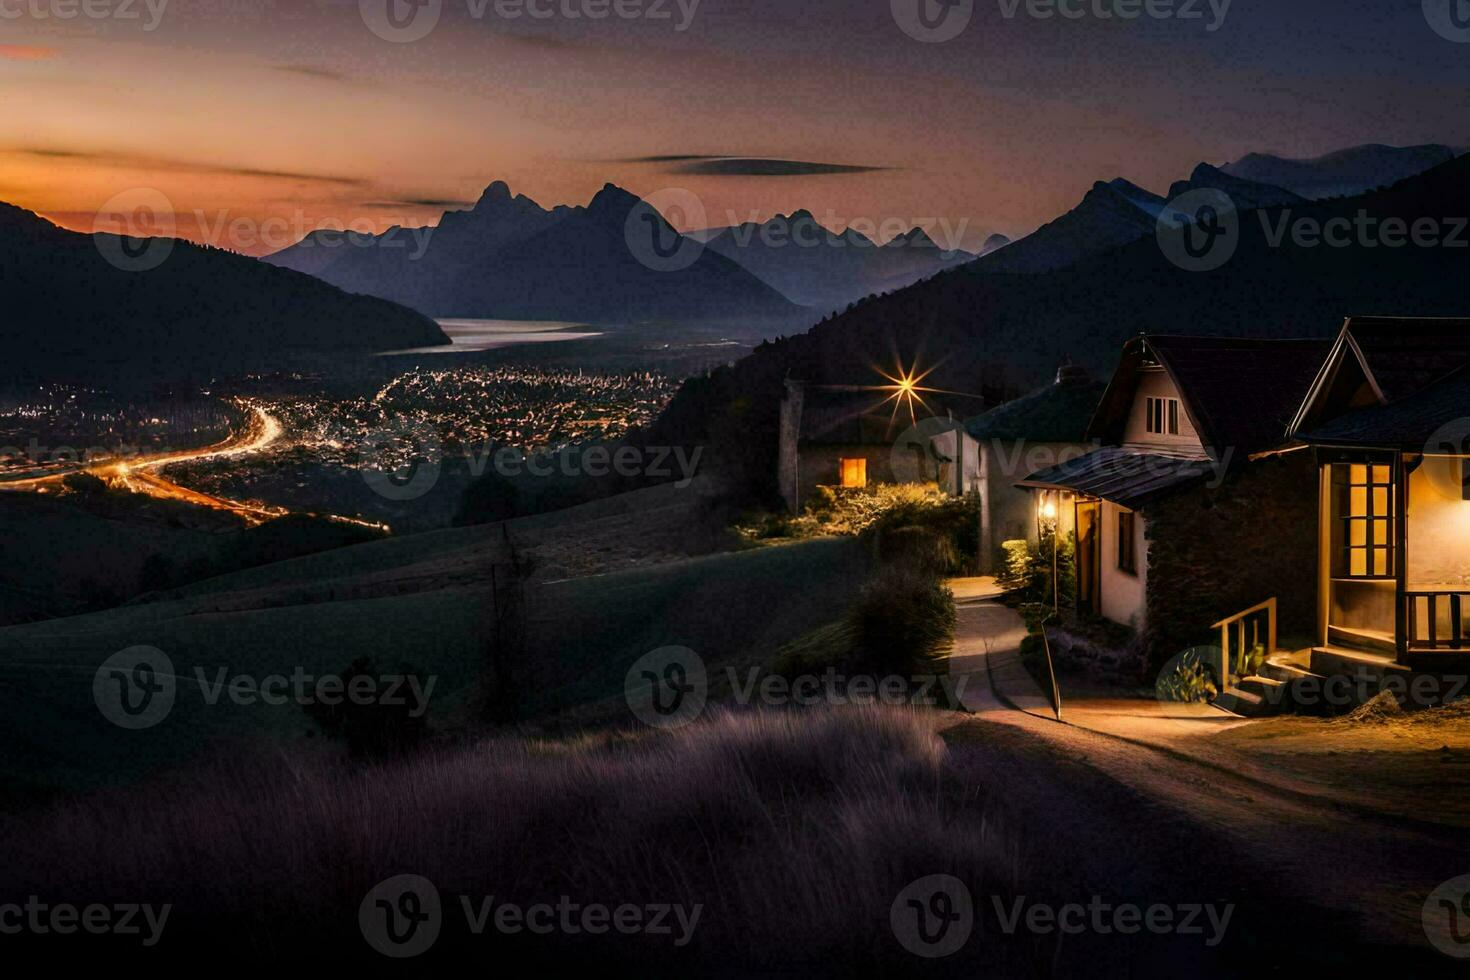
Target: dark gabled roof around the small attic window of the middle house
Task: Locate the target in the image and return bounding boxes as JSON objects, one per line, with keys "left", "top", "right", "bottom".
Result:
{"left": 1088, "top": 335, "right": 1329, "bottom": 460}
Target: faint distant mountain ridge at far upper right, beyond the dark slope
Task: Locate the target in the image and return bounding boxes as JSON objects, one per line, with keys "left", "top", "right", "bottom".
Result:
{"left": 1223, "top": 143, "right": 1455, "bottom": 200}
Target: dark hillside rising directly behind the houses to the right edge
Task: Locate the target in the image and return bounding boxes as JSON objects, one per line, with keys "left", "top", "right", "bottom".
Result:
{"left": 651, "top": 157, "right": 1470, "bottom": 505}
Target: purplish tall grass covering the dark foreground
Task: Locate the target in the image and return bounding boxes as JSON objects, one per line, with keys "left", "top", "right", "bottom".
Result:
{"left": 0, "top": 708, "right": 1020, "bottom": 976}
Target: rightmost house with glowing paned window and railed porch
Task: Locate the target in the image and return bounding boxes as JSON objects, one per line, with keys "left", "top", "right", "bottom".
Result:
{"left": 1288, "top": 317, "right": 1470, "bottom": 673}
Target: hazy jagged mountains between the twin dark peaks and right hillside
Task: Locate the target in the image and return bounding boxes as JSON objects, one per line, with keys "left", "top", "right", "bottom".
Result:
{"left": 704, "top": 210, "right": 975, "bottom": 310}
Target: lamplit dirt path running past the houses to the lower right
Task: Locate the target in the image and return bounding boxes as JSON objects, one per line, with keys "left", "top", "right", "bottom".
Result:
{"left": 945, "top": 579, "right": 1470, "bottom": 948}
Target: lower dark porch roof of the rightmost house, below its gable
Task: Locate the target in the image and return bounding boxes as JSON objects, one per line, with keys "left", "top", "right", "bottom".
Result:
{"left": 1299, "top": 366, "right": 1470, "bottom": 453}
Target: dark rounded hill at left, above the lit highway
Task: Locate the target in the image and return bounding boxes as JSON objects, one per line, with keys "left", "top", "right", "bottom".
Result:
{"left": 0, "top": 203, "right": 448, "bottom": 379}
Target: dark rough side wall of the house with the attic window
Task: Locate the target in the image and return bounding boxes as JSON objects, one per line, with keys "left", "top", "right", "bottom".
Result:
{"left": 1142, "top": 451, "right": 1317, "bottom": 673}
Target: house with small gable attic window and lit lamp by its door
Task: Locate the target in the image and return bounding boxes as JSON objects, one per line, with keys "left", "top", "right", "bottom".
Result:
{"left": 1019, "top": 335, "right": 1327, "bottom": 673}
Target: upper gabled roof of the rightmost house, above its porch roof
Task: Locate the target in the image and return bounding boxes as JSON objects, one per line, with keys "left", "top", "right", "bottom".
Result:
{"left": 1291, "top": 316, "right": 1470, "bottom": 435}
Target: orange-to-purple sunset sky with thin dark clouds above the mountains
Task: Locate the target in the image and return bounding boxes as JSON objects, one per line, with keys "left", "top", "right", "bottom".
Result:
{"left": 0, "top": 0, "right": 1470, "bottom": 253}
